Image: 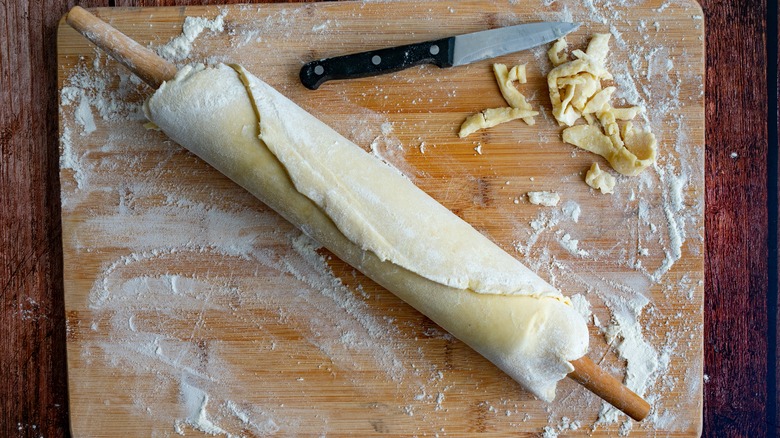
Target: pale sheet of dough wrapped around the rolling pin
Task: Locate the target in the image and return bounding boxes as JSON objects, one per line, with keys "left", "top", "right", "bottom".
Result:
{"left": 144, "top": 65, "right": 588, "bottom": 401}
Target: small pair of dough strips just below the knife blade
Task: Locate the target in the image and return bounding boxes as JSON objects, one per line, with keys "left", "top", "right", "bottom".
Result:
{"left": 458, "top": 64, "right": 539, "bottom": 138}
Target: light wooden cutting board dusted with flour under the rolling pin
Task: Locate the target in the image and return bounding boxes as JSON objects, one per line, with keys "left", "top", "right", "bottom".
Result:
{"left": 57, "top": 0, "right": 704, "bottom": 436}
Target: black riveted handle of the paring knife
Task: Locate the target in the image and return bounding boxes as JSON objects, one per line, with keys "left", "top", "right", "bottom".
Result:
{"left": 301, "top": 37, "right": 455, "bottom": 90}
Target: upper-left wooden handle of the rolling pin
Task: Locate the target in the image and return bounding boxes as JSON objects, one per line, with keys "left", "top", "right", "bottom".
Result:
{"left": 65, "top": 6, "right": 176, "bottom": 88}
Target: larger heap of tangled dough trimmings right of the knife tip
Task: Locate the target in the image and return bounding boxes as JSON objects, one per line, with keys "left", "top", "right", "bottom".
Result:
{"left": 547, "top": 34, "right": 657, "bottom": 176}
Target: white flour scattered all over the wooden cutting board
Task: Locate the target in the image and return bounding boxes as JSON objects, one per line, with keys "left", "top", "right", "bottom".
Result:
{"left": 60, "top": 0, "right": 704, "bottom": 437}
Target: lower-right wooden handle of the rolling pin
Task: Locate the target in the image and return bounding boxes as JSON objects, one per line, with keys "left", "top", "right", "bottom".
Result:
{"left": 568, "top": 357, "right": 650, "bottom": 421}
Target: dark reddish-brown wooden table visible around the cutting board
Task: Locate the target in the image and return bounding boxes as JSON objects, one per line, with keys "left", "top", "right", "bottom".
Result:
{"left": 0, "top": 0, "right": 780, "bottom": 437}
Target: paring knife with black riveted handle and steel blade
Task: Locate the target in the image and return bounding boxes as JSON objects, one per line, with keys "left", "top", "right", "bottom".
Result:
{"left": 300, "top": 22, "right": 580, "bottom": 90}
